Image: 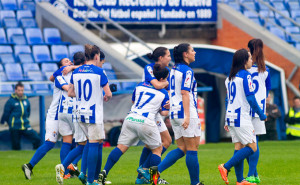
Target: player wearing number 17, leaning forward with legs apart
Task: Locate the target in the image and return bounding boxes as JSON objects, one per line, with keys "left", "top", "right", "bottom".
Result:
{"left": 99, "top": 64, "right": 169, "bottom": 184}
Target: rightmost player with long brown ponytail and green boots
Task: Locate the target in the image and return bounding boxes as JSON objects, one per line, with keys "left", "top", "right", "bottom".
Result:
{"left": 246, "top": 39, "right": 271, "bottom": 183}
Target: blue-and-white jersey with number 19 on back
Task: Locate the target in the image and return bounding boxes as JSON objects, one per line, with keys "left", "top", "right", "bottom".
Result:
{"left": 225, "top": 70, "right": 254, "bottom": 127}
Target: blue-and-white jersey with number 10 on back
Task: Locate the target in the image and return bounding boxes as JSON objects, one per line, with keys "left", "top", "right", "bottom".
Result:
{"left": 70, "top": 65, "right": 108, "bottom": 124}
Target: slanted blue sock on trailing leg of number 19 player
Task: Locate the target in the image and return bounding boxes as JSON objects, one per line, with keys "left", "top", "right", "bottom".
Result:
{"left": 224, "top": 146, "right": 254, "bottom": 170}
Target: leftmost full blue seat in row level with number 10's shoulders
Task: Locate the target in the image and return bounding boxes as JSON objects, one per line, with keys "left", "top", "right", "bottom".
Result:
{"left": 4, "top": 63, "right": 24, "bottom": 81}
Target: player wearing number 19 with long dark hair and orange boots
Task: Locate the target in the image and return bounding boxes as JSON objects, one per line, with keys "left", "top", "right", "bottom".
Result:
{"left": 218, "top": 49, "right": 267, "bottom": 185}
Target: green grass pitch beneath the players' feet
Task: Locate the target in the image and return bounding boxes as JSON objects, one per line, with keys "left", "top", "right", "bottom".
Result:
{"left": 0, "top": 141, "right": 300, "bottom": 185}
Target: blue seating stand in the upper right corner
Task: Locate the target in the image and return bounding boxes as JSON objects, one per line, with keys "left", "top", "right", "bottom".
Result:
{"left": 219, "top": 0, "right": 300, "bottom": 50}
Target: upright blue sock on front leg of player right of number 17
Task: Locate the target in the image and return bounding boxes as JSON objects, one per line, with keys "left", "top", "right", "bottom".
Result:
{"left": 185, "top": 151, "right": 200, "bottom": 185}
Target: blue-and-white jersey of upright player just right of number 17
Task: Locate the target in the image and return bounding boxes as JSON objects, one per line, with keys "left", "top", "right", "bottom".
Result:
{"left": 170, "top": 64, "right": 198, "bottom": 119}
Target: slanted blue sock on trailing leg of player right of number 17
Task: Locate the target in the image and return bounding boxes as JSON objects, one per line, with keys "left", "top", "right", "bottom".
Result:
{"left": 158, "top": 148, "right": 184, "bottom": 173}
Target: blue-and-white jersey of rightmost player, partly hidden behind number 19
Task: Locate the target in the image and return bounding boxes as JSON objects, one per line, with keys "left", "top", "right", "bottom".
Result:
{"left": 248, "top": 64, "right": 271, "bottom": 117}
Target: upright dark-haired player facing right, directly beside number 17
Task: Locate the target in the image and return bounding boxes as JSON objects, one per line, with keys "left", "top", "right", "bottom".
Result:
{"left": 152, "top": 43, "right": 202, "bottom": 185}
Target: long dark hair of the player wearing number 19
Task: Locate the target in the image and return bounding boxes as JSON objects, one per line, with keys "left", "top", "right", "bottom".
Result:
{"left": 229, "top": 49, "right": 249, "bottom": 80}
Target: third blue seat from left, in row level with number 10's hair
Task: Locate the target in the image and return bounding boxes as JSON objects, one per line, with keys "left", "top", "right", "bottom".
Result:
{"left": 32, "top": 45, "right": 52, "bottom": 62}
